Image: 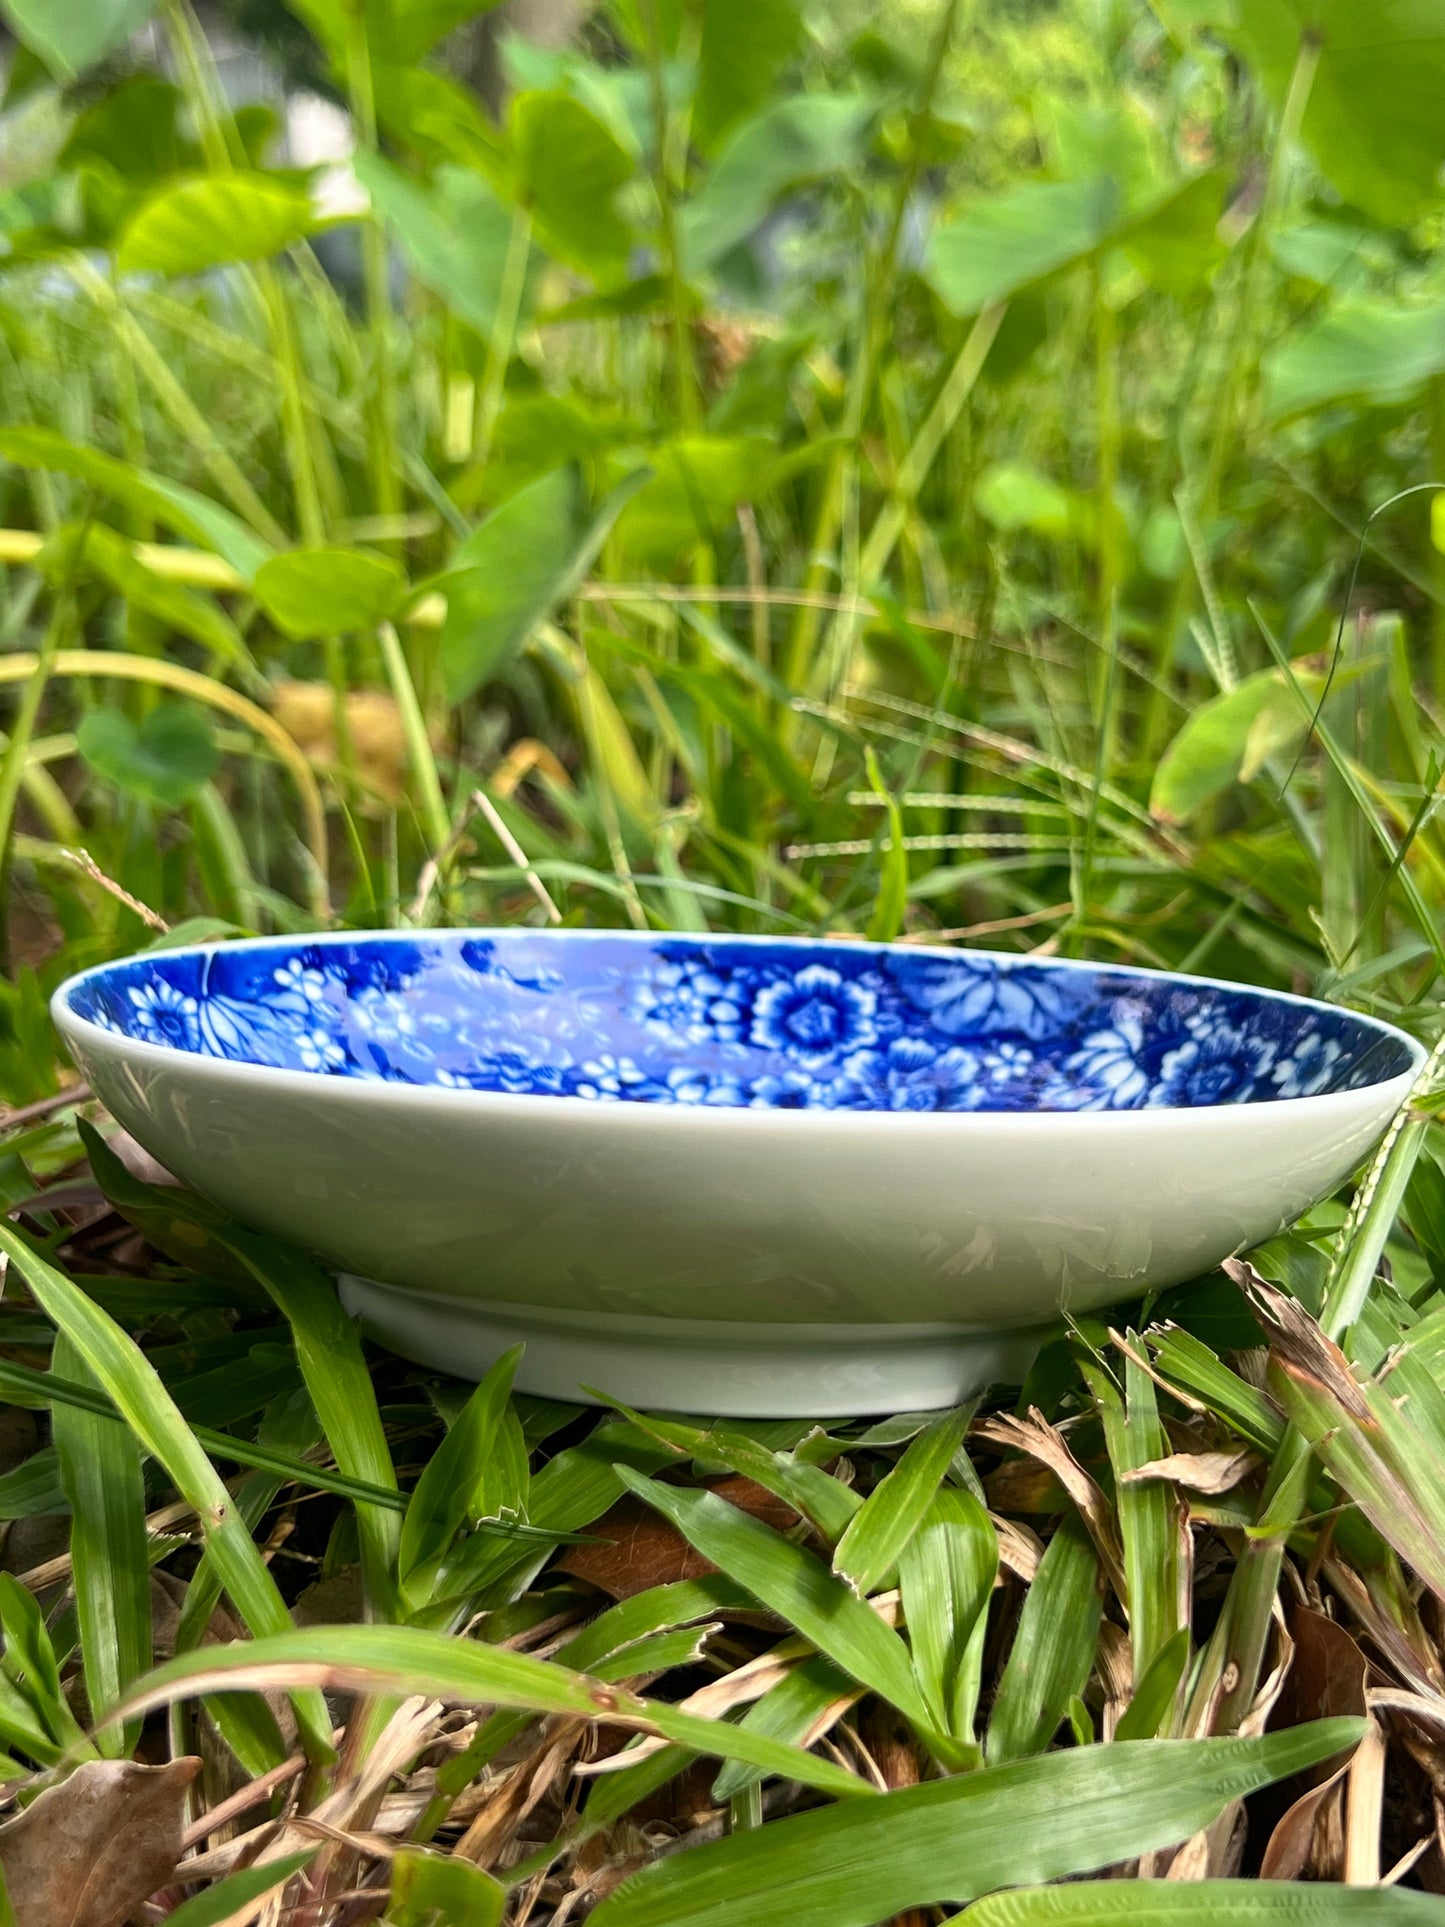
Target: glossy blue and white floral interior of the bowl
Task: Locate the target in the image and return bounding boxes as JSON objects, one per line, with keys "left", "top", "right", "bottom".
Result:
{"left": 69, "top": 931, "right": 1412, "bottom": 1112}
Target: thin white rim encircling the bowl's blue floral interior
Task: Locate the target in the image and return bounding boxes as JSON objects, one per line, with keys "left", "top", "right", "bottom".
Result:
{"left": 50, "top": 923, "right": 1430, "bottom": 1135}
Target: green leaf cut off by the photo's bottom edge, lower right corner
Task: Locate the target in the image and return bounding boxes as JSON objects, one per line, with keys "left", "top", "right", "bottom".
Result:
{"left": 963, "top": 1881, "right": 1445, "bottom": 1927}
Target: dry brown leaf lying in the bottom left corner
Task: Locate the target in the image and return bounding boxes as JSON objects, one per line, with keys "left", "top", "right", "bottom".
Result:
{"left": 0, "top": 1757, "right": 200, "bottom": 1927}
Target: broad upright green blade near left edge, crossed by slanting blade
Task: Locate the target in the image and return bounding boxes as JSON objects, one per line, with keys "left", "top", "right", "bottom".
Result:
{"left": 50, "top": 1337, "right": 150, "bottom": 1759}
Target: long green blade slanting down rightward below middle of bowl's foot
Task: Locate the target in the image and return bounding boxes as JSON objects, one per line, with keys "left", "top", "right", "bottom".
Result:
{"left": 618, "top": 1466, "right": 929, "bottom": 1727}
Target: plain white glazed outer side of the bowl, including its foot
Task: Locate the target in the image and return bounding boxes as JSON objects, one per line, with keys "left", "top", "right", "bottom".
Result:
{"left": 54, "top": 938, "right": 1420, "bottom": 1416}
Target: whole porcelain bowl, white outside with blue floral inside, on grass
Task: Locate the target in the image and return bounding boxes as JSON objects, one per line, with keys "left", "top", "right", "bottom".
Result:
{"left": 54, "top": 929, "right": 1422, "bottom": 1416}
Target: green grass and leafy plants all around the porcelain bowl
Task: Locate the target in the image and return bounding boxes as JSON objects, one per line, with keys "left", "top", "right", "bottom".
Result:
{"left": 0, "top": 0, "right": 1445, "bottom": 1927}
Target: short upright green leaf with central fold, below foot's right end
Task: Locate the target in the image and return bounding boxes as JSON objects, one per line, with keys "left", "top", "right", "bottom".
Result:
{"left": 898, "top": 1486, "right": 998, "bottom": 1744}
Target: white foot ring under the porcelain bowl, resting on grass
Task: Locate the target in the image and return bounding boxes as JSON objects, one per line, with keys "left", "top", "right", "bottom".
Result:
{"left": 341, "top": 1276, "right": 1044, "bottom": 1418}
